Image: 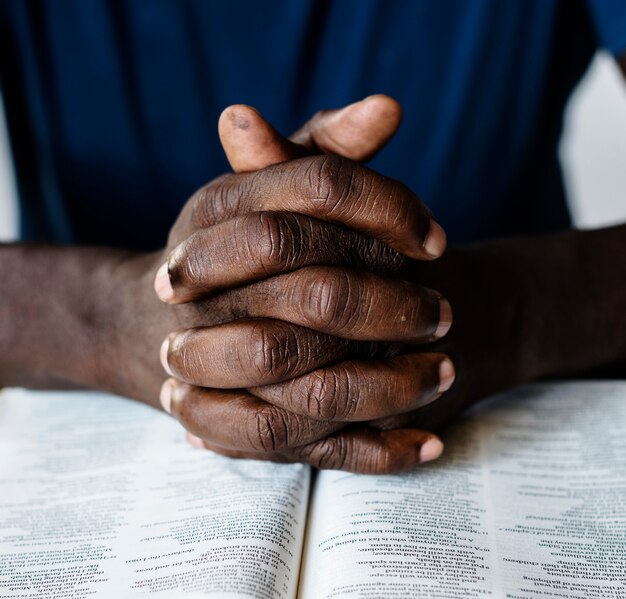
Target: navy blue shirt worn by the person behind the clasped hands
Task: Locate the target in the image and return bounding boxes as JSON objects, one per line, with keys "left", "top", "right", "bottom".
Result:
{"left": 0, "top": 0, "right": 626, "bottom": 249}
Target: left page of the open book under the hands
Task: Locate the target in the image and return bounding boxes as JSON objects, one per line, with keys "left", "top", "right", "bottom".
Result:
{"left": 0, "top": 390, "right": 310, "bottom": 599}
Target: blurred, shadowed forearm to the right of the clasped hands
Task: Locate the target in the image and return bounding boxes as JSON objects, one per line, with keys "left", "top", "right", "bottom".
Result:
{"left": 426, "top": 226, "right": 626, "bottom": 399}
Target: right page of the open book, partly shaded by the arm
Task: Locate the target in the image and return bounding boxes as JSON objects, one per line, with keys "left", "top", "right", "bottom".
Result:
{"left": 299, "top": 382, "right": 626, "bottom": 599}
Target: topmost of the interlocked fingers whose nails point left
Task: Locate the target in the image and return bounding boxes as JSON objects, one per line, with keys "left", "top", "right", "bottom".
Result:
{"left": 157, "top": 212, "right": 406, "bottom": 304}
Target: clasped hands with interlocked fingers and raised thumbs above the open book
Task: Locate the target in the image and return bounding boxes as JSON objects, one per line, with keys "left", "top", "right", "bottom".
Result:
{"left": 155, "top": 97, "right": 454, "bottom": 472}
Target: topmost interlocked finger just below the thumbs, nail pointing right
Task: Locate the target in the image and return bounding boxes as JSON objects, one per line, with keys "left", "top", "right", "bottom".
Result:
{"left": 185, "top": 155, "right": 446, "bottom": 260}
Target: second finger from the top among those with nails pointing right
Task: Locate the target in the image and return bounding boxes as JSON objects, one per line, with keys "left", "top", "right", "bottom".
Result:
{"left": 214, "top": 266, "right": 452, "bottom": 343}
